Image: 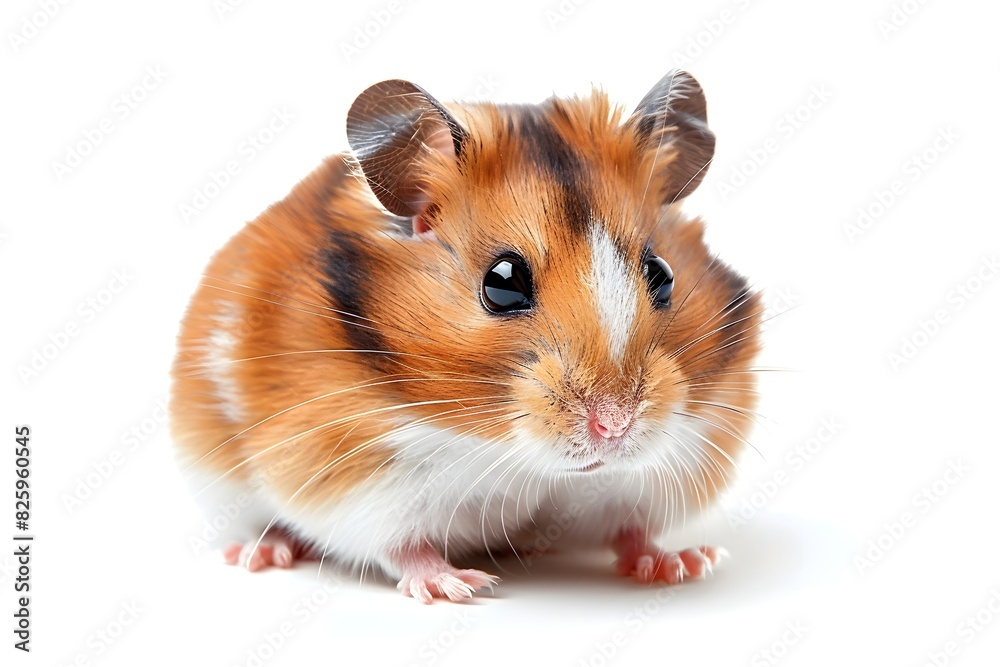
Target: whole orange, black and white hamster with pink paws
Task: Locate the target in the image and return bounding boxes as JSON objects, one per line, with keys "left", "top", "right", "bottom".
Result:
{"left": 170, "top": 71, "right": 762, "bottom": 603}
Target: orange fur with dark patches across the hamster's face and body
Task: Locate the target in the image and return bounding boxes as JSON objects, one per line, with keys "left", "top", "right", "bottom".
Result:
{"left": 171, "top": 83, "right": 760, "bottom": 524}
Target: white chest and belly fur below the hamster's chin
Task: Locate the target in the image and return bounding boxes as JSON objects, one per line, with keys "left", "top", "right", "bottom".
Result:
{"left": 270, "top": 426, "right": 676, "bottom": 576}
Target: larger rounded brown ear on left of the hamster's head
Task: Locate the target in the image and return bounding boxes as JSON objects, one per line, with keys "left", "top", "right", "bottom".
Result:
{"left": 347, "top": 79, "right": 465, "bottom": 216}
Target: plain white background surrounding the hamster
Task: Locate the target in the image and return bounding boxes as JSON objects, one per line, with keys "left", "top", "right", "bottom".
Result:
{"left": 0, "top": 0, "right": 1000, "bottom": 667}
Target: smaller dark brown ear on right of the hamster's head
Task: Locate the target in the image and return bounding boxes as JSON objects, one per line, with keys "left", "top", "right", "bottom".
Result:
{"left": 626, "top": 70, "right": 715, "bottom": 204}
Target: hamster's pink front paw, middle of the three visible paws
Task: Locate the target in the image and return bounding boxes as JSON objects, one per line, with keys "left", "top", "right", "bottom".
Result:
{"left": 394, "top": 545, "right": 500, "bottom": 604}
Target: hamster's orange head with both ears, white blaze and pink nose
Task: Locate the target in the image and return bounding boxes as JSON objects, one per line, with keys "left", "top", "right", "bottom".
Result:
{"left": 336, "top": 71, "right": 760, "bottom": 488}
